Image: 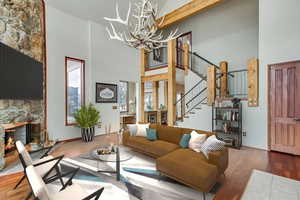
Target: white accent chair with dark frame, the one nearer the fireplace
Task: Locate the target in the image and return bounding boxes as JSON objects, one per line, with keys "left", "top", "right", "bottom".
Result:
{"left": 14, "top": 141, "right": 64, "bottom": 189}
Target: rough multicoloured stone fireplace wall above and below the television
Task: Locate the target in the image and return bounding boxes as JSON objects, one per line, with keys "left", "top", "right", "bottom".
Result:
{"left": 0, "top": 0, "right": 45, "bottom": 124}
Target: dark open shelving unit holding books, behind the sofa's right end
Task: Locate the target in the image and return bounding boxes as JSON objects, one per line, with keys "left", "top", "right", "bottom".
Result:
{"left": 212, "top": 103, "right": 243, "bottom": 149}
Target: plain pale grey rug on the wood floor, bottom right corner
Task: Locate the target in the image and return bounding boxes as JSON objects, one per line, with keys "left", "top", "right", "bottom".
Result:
{"left": 241, "top": 170, "right": 300, "bottom": 200}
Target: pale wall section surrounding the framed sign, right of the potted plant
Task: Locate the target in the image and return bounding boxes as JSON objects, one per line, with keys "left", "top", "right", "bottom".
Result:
{"left": 89, "top": 22, "right": 140, "bottom": 134}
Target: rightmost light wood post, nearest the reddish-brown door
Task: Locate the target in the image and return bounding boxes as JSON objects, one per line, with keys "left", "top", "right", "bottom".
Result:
{"left": 248, "top": 58, "right": 259, "bottom": 107}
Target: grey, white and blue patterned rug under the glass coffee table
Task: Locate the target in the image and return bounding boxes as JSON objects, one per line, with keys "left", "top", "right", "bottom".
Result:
{"left": 63, "top": 147, "right": 214, "bottom": 200}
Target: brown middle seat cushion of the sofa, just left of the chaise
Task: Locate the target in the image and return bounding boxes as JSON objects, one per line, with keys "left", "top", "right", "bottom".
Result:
{"left": 146, "top": 140, "right": 180, "bottom": 157}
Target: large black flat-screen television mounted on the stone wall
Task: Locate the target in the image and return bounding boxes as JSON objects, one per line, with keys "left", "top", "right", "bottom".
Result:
{"left": 0, "top": 42, "right": 43, "bottom": 100}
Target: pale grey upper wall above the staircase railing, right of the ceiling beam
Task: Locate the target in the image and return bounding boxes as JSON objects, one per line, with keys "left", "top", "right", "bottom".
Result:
{"left": 166, "top": 0, "right": 259, "bottom": 69}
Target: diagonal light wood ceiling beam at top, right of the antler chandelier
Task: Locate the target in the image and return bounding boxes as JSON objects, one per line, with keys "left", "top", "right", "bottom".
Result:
{"left": 158, "top": 0, "right": 224, "bottom": 29}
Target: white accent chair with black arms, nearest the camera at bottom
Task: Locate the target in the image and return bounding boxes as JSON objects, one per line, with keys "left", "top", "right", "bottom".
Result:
{"left": 26, "top": 165, "right": 104, "bottom": 200}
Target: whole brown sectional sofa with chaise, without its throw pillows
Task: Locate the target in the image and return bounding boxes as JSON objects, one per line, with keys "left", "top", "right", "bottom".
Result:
{"left": 123, "top": 124, "right": 228, "bottom": 192}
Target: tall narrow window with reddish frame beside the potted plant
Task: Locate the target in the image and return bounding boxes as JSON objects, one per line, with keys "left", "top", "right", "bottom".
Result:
{"left": 65, "top": 57, "right": 85, "bottom": 126}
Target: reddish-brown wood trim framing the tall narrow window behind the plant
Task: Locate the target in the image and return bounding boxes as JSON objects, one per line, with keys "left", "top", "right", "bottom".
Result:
{"left": 65, "top": 56, "right": 85, "bottom": 126}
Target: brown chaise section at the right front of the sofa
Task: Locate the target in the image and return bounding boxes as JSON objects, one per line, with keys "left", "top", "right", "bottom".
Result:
{"left": 156, "top": 149, "right": 218, "bottom": 192}
